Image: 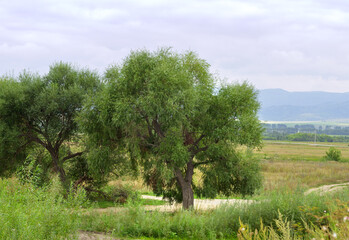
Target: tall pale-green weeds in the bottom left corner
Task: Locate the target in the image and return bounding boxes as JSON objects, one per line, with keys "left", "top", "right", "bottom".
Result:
{"left": 0, "top": 179, "right": 80, "bottom": 239}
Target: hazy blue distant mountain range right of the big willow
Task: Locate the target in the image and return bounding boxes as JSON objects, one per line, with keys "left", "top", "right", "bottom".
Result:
{"left": 259, "top": 89, "right": 349, "bottom": 121}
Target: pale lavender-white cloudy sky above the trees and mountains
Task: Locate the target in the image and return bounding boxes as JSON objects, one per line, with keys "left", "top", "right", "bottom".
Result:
{"left": 0, "top": 0, "right": 349, "bottom": 92}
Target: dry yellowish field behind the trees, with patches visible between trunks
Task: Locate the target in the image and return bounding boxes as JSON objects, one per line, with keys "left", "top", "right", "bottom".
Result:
{"left": 109, "top": 141, "right": 349, "bottom": 194}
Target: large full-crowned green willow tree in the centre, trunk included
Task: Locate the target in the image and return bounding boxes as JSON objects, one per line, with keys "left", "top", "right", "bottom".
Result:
{"left": 84, "top": 49, "right": 262, "bottom": 209}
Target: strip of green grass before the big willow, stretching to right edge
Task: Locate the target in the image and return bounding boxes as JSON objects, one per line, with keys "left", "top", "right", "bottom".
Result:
{"left": 81, "top": 188, "right": 349, "bottom": 239}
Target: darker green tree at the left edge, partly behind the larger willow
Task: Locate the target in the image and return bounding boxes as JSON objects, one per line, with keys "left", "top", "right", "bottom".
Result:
{"left": 0, "top": 63, "right": 100, "bottom": 183}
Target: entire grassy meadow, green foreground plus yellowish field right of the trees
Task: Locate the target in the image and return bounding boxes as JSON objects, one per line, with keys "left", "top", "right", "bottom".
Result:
{"left": 0, "top": 142, "right": 349, "bottom": 239}
